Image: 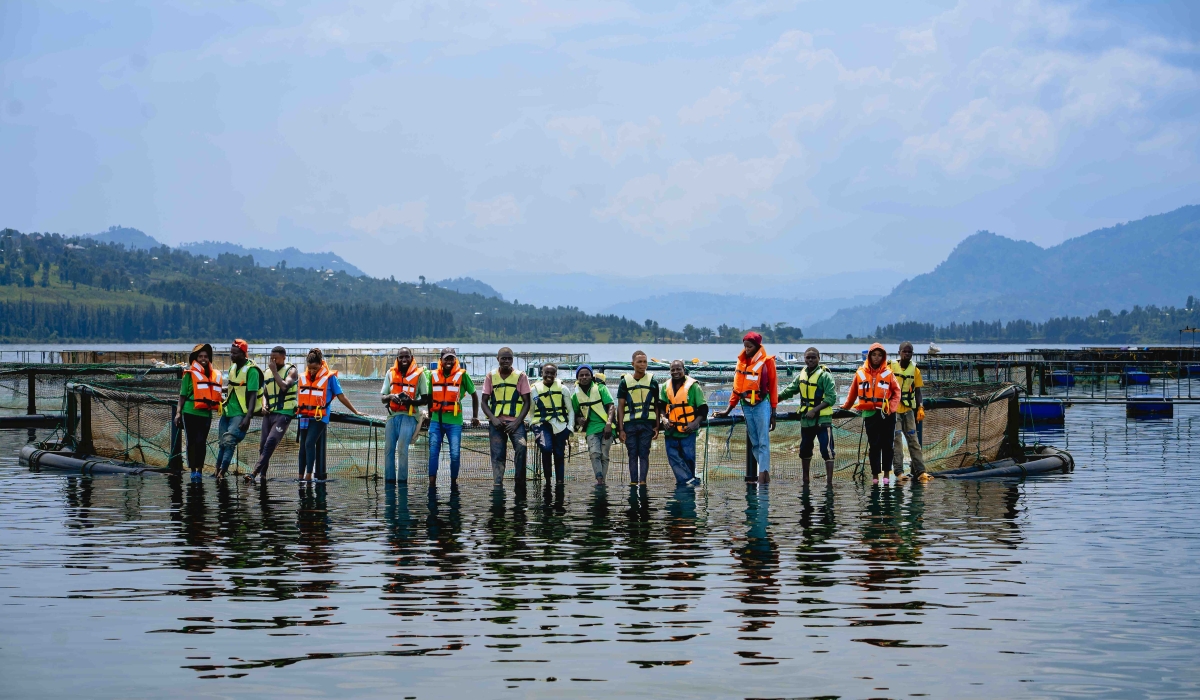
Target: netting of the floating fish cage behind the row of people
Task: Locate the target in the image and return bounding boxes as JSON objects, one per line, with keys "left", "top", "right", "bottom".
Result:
{"left": 7, "top": 358, "right": 1022, "bottom": 485}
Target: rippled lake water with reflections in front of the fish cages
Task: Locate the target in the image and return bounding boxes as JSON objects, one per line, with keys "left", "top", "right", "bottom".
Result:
{"left": 0, "top": 407, "right": 1200, "bottom": 699}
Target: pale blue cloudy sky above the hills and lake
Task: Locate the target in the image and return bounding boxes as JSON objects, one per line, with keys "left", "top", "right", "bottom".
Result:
{"left": 0, "top": 0, "right": 1200, "bottom": 284}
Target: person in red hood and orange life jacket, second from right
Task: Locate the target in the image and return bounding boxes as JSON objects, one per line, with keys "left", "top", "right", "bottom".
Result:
{"left": 842, "top": 342, "right": 900, "bottom": 486}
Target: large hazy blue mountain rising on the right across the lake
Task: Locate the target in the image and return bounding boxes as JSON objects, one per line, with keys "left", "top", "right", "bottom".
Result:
{"left": 804, "top": 205, "right": 1200, "bottom": 337}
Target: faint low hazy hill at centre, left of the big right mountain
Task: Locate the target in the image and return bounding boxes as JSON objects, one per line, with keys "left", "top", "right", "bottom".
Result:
{"left": 602, "top": 292, "right": 881, "bottom": 330}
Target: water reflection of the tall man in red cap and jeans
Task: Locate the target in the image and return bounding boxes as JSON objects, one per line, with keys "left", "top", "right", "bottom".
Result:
{"left": 733, "top": 484, "right": 779, "bottom": 632}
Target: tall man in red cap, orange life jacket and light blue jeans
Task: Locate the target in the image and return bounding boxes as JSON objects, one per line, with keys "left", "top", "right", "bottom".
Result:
{"left": 713, "top": 330, "right": 779, "bottom": 484}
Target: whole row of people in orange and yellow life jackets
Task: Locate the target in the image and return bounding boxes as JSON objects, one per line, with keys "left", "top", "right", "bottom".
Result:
{"left": 175, "top": 331, "right": 929, "bottom": 486}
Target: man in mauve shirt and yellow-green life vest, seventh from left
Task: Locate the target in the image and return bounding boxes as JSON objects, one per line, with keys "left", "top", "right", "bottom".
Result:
{"left": 480, "top": 347, "right": 530, "bottom": 486}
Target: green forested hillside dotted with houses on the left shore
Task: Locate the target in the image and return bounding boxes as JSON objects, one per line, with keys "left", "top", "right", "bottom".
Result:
{"left": 0, "top": 229, "right": 679, "bottom": 342}
